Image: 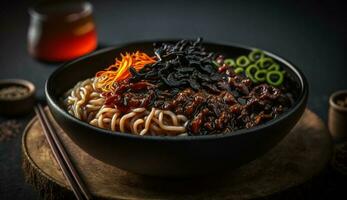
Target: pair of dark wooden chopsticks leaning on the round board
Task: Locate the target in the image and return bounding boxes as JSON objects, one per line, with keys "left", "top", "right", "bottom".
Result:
{"left": 34, "top": 104, "right": 92, "bottom": 200}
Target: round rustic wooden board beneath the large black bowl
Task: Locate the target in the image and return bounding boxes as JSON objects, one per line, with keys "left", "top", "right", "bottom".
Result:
{"left": 22, "top": 110, "right": 332, "bottom": 199}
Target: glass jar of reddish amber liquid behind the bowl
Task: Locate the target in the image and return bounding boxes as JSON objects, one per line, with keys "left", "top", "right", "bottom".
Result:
{"left": 28, "top": 1, "right": 97, "bottom": 62}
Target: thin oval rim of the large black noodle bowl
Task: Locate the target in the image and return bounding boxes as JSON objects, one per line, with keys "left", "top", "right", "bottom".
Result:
{"left": 45, "top": 39, "right": 309, "bottom": 142}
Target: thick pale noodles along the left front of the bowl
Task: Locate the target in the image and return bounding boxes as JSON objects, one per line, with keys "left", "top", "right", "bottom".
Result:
{"left": 64, "top": 78, "right": 188, "bottom": 135}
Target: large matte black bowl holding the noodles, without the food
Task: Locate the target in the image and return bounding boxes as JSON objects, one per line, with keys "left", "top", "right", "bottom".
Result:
{"left": 45, "top": 41, "right": 308, "bottom": 177}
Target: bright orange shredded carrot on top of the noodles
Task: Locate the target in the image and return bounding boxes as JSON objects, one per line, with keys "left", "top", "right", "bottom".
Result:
{"left": 96, "top": 51, "right": 156, "bottom": 92}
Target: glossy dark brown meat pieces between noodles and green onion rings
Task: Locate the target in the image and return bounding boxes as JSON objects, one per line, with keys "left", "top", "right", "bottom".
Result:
{"left": 154, "top": 83, "right": 290, "bottom": 135}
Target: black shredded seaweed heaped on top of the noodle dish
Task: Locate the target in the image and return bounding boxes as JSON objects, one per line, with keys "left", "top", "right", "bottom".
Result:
{"left": 130, "top": 38, "right": 225, "bottom": 93}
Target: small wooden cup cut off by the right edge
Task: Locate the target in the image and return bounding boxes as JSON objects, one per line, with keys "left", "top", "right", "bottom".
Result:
{"left": 328, "top": 90, "right": 347, "bottom": 141}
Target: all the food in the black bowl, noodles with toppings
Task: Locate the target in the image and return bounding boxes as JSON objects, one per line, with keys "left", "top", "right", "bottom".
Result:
{"left": 63, "top": 39, "right": 296, "bottom": 136}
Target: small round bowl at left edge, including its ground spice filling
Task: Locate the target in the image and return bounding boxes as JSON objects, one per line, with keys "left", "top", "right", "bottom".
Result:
{"left": 0, "top": 79, "right": 35, "bottom": 115}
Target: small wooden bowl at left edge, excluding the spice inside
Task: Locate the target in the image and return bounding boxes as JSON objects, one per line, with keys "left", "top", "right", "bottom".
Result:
{"left": 0, "top": 79, "right": 35, "bottom": 116}
